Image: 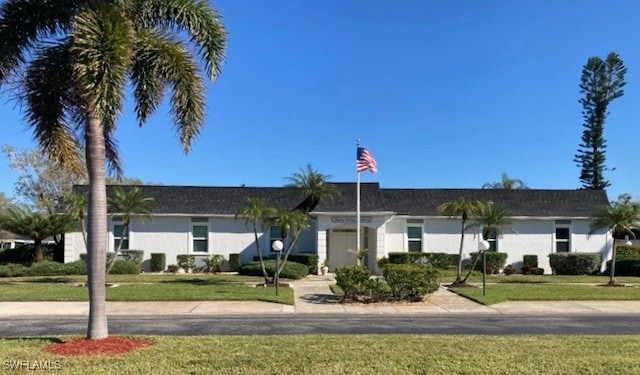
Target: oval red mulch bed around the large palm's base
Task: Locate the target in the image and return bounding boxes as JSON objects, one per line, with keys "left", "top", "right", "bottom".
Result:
{"left": 44, "top": 336, "right": 151, "bottom": 356}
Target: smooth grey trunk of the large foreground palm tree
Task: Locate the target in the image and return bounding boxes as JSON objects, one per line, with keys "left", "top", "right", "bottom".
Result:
{"left": 85, "top": 115, "right": 109, "bottom": 340}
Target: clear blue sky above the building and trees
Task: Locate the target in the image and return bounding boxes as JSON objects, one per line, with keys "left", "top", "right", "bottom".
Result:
{"left": 0, "top": 0, "right": 640, "bottom": 203}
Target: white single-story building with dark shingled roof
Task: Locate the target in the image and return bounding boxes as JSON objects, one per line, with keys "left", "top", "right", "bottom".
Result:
{"left": 64, "top": 183, "right": 613, "bottom": 273}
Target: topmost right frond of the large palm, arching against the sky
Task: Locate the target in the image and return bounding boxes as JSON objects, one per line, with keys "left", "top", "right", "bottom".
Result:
{"left": 130, "top": 0, "right": 227, "bottom": 80}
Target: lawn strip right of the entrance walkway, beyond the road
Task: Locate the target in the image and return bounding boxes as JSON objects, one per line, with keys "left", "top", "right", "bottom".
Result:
{"left": 450, "top": 282, "right": 640, "bottom": 305}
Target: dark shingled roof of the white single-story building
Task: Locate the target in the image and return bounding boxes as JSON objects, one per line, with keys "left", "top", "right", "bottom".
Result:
{"left": 75, "top": 182, "right": 608, "bottom": 217}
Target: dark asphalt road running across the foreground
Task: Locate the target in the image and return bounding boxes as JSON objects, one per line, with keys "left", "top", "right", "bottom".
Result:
{"left": 0, "top": 314, "right": 640, "bottom": 337}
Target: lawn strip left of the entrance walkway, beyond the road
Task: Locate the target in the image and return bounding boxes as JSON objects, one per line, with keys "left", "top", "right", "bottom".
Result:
{"left": 0, "top": 275, "right": 294, "bottom": 305}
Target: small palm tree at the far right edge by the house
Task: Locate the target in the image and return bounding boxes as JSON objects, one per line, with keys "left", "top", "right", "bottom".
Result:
{"left": 589, "top": 194, "right": 640, "bottom": 285}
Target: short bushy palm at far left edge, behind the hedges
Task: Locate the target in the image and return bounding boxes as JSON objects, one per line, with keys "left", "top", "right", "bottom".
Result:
{"left": 0, "top": 206, "right": 74, "bottom": 262}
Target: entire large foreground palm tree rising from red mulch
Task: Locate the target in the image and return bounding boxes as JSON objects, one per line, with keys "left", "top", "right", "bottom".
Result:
{"left": 0, "top": 0, "right": 226, "bottom": 339}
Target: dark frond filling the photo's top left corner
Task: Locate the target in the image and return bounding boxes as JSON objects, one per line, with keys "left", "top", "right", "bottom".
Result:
{"left": 0, "top": 0, "right": 87, "bottom": 84}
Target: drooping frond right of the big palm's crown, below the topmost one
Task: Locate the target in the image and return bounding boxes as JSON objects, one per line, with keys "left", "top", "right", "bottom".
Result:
{"left": 134, "top": 34, "right": 205, "bottom": 153}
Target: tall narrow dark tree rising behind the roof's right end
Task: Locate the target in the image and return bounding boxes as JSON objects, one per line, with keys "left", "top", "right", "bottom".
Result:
{"left": 573, "top": 52, "right": 627, "bottom": 190}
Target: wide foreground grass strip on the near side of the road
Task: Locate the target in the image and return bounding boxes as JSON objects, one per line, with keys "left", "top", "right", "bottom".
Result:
{"left": 0, "top": 335, "right": 640, "bottom": 375}
